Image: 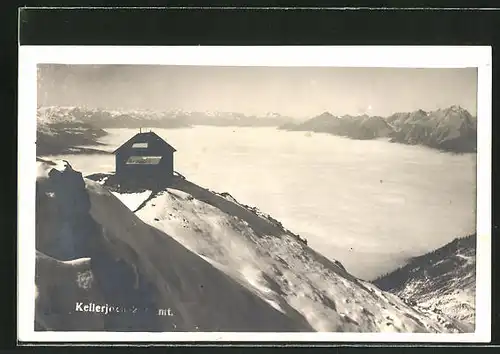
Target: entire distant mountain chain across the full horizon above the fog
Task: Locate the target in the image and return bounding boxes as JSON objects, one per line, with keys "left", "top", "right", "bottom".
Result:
{"left": 37, "top": 106, "right": 477, "bottom": 154}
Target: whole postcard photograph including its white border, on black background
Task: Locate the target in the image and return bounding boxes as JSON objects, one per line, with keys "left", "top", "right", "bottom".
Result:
{"left": 18, "top": 47, "right": 491, "bottom": 342}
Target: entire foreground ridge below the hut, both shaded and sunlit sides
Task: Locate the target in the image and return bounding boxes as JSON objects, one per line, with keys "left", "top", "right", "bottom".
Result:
{"left": 36, "top": 160, "right": 472, "bottom": 332}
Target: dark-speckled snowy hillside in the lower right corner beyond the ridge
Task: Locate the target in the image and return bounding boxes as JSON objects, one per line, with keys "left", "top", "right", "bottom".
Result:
{"left": 375, "top": 235, "right": 476, "bottom": 332}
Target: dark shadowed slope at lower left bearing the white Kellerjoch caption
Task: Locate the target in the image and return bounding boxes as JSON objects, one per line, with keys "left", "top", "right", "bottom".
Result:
{"left": 35, "top": 161, "right": 313, "bottom": 332}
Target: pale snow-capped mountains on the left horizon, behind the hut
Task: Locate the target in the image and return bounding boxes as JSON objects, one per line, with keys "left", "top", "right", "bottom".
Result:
{"left": 37, "top": 106, "right": 300, "bottom": 155}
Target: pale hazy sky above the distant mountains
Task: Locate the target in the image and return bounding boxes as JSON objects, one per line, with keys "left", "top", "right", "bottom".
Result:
{"left": 38, "top": 65, "right": 477, "bottom": 117}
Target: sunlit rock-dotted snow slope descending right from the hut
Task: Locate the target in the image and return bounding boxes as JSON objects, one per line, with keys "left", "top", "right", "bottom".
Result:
{"left": 101, "top": 179, "right": 459, "bottom": 332}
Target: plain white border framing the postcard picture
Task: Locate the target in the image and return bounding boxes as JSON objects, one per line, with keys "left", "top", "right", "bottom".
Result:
{"left": 18, "top": 46, "right": 492, "bottom": 343}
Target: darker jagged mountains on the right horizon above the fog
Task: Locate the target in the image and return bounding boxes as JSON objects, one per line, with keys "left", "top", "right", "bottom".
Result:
{"left": 279, "top": 106, "right": 477, "bottom": 153}
